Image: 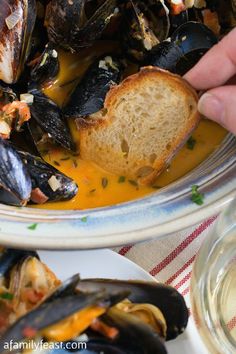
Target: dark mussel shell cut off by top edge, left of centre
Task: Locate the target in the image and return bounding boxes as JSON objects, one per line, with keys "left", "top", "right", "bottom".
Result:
{"left": 45, "top": 0, "right": 117, "bottom": 52}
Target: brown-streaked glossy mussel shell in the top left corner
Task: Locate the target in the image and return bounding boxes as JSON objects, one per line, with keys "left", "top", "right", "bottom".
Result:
{"left": 0, "top": 0, "right": 36, "bottom": 84}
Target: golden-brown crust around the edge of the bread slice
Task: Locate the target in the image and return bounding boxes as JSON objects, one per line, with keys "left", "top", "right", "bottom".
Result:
{"left": 79, "top": 66, "right": 200, "bottom": 185}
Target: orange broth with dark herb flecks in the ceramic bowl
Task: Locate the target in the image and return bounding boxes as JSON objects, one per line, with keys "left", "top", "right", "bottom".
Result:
{"left": 34, "top": 43, "right": 227, "bottom": 210}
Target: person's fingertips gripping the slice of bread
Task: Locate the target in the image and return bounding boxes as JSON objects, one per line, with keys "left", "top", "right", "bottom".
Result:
{"left": 184, "top": 28, "right": 236, "bottom": 134}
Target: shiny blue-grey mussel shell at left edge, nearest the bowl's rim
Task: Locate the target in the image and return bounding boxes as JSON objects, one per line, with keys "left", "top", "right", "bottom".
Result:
{"left": 0, "top": 138, "right": 32, "bottom": 206}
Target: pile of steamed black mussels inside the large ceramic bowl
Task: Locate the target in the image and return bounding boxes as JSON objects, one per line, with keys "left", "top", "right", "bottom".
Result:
{"left": 0, "top": 0, "right": 235, "bottom": 206}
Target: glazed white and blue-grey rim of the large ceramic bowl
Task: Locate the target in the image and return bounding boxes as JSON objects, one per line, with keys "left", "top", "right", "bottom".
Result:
{"left": 0, "top": 134, "right": 236, "bottom": 249}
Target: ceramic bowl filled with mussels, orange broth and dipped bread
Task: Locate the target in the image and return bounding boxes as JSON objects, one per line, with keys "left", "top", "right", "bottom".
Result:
{"left": 0, "top": 0, "right": 236, "bottom": 249}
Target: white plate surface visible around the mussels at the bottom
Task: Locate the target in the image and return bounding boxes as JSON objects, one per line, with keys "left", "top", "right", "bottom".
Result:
{"left": 39, "top": 250, "right": 208, "bottom": 354}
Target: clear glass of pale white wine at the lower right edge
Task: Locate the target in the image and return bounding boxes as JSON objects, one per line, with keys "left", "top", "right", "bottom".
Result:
{"left": 191, "top": 199, "right": 236, "bottom": 354}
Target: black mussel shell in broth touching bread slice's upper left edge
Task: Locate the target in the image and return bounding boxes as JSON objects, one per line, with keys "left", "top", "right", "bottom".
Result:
{"left": 63, "top": 56, "right": 123, "bottom": 118}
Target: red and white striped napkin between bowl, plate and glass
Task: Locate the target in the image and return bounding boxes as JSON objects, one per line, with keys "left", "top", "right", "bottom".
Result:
{"left": 114, "top": 216, "right": 217, "bottom": 302}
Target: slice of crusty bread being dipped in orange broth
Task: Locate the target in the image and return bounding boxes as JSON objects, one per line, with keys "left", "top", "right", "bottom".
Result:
{"left": 77, "top": 67, "right": 199, "bottom": 184}
